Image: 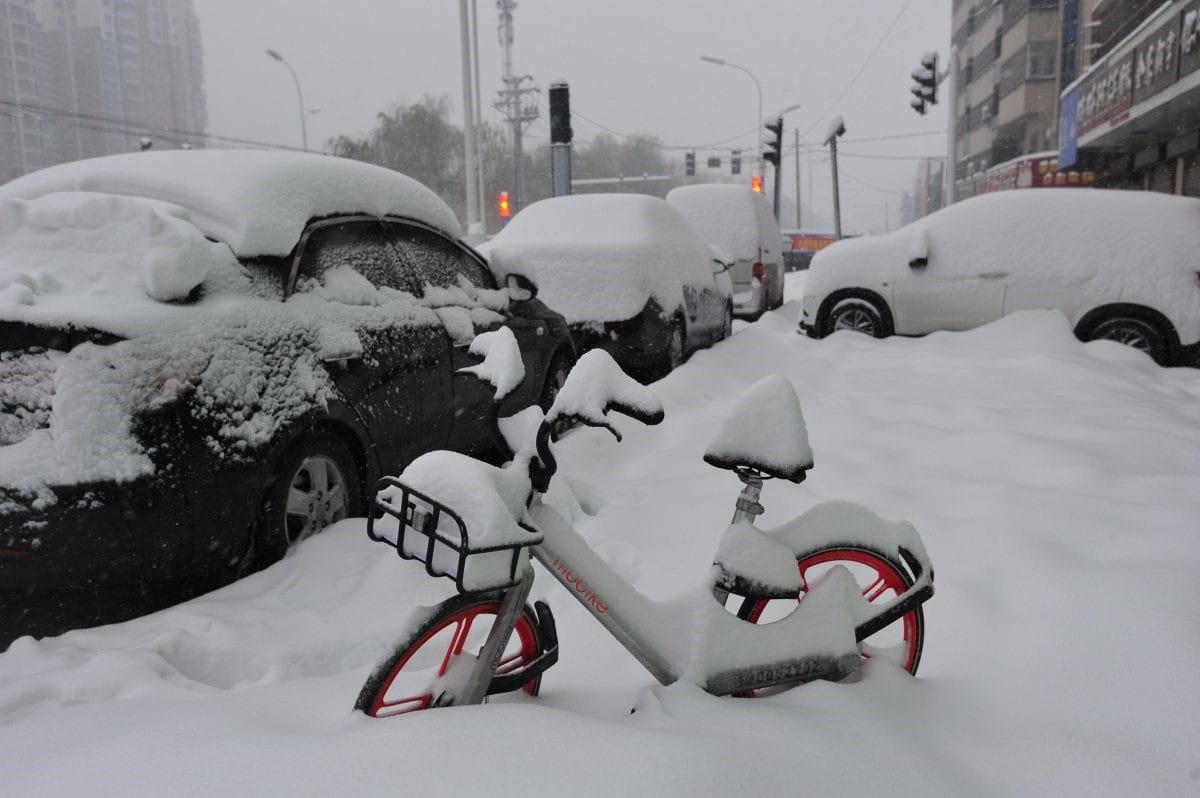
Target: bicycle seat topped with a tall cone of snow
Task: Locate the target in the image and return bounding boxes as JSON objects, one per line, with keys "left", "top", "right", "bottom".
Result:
{"left": 704, "top": 374, "right": 812, "bottom": 482}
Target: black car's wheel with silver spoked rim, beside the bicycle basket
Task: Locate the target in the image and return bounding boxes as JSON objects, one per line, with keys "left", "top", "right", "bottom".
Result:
{"left": 251, "top": 431, "right": 364, "bottom": 570}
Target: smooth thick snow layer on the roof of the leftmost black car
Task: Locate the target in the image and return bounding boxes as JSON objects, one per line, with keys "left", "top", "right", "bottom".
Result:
{"left": 0, "top": 150, "right": 461, "bottom": 257}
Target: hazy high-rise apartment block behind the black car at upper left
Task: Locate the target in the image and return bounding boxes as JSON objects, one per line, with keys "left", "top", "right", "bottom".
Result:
{"left": 0, "top": 0, "right": 208, "bottom": 181}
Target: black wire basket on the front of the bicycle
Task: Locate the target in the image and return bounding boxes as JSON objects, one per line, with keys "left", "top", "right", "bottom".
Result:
{"left": 367, "top": 476, "right": 541, "bottom": 593}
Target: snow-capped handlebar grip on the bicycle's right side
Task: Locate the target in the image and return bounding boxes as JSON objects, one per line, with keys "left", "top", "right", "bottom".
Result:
{"left": 546, "top": 349, "right": 662, "bottom": 440}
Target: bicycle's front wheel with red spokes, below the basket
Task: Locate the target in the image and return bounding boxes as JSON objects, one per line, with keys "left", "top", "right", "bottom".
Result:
{"left": 354, "top": 593, "right": 544, "bottom": 718}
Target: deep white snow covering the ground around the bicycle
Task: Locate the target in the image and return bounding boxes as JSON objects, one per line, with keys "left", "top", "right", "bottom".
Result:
{"left": 0, "top": 272, "right": 1200, "bottom": 797}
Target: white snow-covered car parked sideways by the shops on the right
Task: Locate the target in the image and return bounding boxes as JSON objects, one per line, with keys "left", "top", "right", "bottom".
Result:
{"left": 799, "top": 188, "right": 1200, "bottom": 365}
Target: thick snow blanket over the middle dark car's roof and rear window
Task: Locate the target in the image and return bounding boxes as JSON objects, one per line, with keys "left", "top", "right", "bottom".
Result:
{"left": 480, "top": 194, "right": 713, "bottom": 323}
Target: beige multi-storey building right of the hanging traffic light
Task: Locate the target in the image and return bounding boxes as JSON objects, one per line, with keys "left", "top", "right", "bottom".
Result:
{"left": 952, "top": 0, "right": 1078, "bottom": 199}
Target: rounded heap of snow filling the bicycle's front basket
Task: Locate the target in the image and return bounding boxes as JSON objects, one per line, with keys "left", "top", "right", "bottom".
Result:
{"left": 376, "top": 451, "right": 541, "bottom": 590}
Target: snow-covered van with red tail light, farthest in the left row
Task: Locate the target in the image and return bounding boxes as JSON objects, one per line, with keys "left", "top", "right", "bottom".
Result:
{"left": 667, "top": 184, "right": 784, "bottom": 319}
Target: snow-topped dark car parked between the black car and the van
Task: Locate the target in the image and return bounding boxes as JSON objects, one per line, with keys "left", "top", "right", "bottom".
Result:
{"left": 480, "top": 194, "right": 733, "bottom": 380}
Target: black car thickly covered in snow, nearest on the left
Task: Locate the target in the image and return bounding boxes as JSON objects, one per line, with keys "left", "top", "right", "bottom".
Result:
{"left": 0, "top": 150, "right": 574, "bottom": 633}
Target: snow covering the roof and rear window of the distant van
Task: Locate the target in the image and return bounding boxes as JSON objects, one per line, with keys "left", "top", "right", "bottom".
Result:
{"left": 667, "top": 184, "right": 781, "bottom": 259}
